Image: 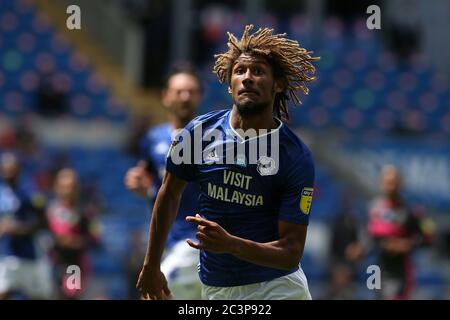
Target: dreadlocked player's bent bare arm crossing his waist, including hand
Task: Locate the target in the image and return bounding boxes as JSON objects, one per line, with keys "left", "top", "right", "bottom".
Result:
{"left": 186, "top": 215, "right": 307, "bottom": 270}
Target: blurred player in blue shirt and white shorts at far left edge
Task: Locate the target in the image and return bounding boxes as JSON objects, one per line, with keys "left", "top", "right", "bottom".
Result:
{"left": 0, "top": 153, "right": 52, "bottom": 299}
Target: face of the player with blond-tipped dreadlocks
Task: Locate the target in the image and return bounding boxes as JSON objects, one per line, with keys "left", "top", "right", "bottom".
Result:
{"left": 229, "top": 54, "right": 281, "bottom": 116}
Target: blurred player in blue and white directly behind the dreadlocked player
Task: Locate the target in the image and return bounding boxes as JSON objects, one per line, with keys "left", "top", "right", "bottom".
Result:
{"left": 125, "top": 66, "right": 202, "bottom": 299}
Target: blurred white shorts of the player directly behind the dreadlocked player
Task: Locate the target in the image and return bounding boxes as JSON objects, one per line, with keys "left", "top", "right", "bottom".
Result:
{"left": 161, "top": 241, "right": 201, "bottom": 300}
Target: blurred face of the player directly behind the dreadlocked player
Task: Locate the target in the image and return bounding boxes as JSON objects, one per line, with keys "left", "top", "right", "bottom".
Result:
{"left": 163, "top": 73, "right": 201, "bottom": 121}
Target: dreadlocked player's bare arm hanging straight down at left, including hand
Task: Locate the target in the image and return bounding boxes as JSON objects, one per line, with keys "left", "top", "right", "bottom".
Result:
{"left": 136, "top": 172, "right": 186, "bottom": 300}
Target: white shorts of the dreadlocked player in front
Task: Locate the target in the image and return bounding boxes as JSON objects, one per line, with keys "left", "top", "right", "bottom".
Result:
{"left": 202, "top": 268, "right": 311, "bottom": 300}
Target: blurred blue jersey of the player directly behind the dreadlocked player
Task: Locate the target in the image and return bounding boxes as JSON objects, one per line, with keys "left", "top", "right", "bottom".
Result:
{"left": 141, "top": 123, "right": 199, "bottom": 247}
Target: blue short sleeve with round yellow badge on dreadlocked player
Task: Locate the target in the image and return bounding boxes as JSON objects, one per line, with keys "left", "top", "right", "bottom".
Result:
{"left": 279, "top": 152, "right": 314, "bottom": 225}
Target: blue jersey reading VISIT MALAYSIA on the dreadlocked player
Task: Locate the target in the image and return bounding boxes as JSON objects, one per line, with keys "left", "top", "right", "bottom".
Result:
{"left": 167, "top": 110, "right": 314, "bottom": 287}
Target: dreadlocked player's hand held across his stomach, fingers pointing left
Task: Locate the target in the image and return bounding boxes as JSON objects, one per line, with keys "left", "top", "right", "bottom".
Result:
{"left": 186, "top": 214, "right": 234, "bottom": 253}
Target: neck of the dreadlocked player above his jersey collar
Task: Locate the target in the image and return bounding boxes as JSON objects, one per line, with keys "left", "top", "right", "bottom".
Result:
{"left": 231, "top": 106, "right": 279, "bottom": 131}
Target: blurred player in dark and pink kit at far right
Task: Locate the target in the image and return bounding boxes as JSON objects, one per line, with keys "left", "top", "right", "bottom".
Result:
{"left": 368, "top": 165, "right": 434, "bottom": 299}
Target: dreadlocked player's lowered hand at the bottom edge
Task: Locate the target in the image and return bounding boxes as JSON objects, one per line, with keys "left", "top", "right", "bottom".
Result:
{"left": 136, "top": 267, "right": 173, "bottom": 300}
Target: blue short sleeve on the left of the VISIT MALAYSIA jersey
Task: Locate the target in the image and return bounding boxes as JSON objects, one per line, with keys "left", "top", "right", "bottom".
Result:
{"left": 166, "top": 120, "right": 196, "bottom": 181}
